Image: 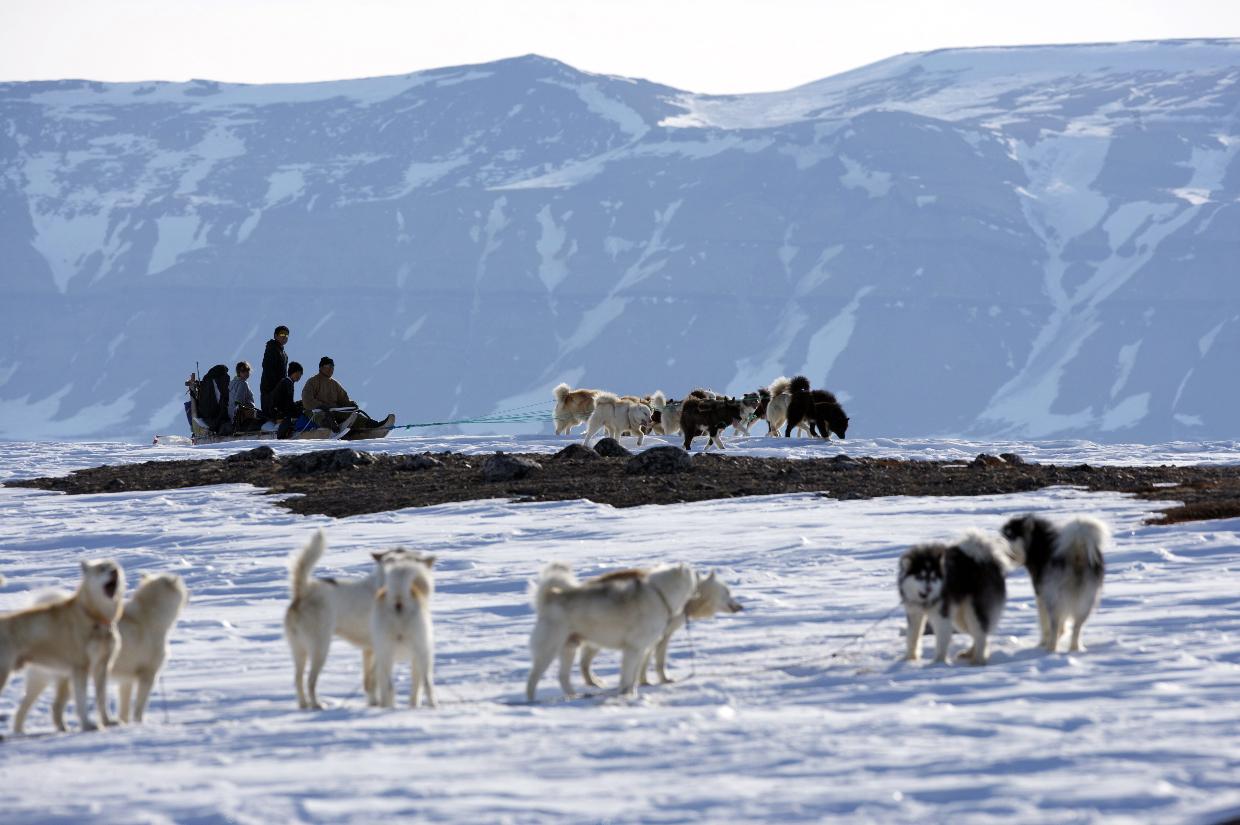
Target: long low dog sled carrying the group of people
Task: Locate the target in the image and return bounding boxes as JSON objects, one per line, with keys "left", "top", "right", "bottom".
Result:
{"left": 177, "top": 371, "right": 396, "bottom": 447}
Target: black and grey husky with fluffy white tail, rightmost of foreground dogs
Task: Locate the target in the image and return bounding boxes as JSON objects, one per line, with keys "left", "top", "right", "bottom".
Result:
{"left": 1003, "top": 515, "right": 1111, "bottom": 653}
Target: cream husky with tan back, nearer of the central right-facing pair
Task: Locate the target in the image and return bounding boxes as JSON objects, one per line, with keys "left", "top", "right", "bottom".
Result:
{"left": 526, "top": 562, "right": 697, "bottom": 702}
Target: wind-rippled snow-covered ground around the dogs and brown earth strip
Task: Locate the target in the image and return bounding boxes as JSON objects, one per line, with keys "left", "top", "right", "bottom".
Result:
{"left": 0, "top": 437, "right": 1240, "bottom": 824}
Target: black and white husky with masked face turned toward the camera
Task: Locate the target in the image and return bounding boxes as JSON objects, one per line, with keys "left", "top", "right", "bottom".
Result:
{"left": 897, "top": 531, "right": 1009, "bottom": 665}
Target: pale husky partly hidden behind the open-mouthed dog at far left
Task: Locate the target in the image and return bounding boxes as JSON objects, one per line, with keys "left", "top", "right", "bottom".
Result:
{"left": 12, "top": 573, "right": 188, "bottom": 733}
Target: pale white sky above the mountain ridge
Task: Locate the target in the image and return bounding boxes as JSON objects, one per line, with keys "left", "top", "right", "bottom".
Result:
{"left": 0, "top": 0, "right": 1240, "bottom": 93}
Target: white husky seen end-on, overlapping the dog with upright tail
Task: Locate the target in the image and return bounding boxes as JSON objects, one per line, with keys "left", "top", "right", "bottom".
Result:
{"left": 371, "top": 556, "right": 436, "bottom": 707}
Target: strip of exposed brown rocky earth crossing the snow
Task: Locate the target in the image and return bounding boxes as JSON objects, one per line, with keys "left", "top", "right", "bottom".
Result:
{"left": 6, "top": 447, "right": 1240, "bottom": 524}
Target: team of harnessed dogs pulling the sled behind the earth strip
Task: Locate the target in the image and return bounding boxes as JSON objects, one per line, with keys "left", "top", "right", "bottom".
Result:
{"left": 552, "top": 376, "right": 848, "bottom": 449}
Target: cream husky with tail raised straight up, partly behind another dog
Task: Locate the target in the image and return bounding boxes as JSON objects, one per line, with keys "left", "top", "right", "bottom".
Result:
{"left": 284, "top": 530, "right": 426, "bottom": 710}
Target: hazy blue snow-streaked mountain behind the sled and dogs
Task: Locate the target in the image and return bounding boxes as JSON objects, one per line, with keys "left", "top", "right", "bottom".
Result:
{"left": 0, "top": 40, "right": 1240, "bottom": 440}
